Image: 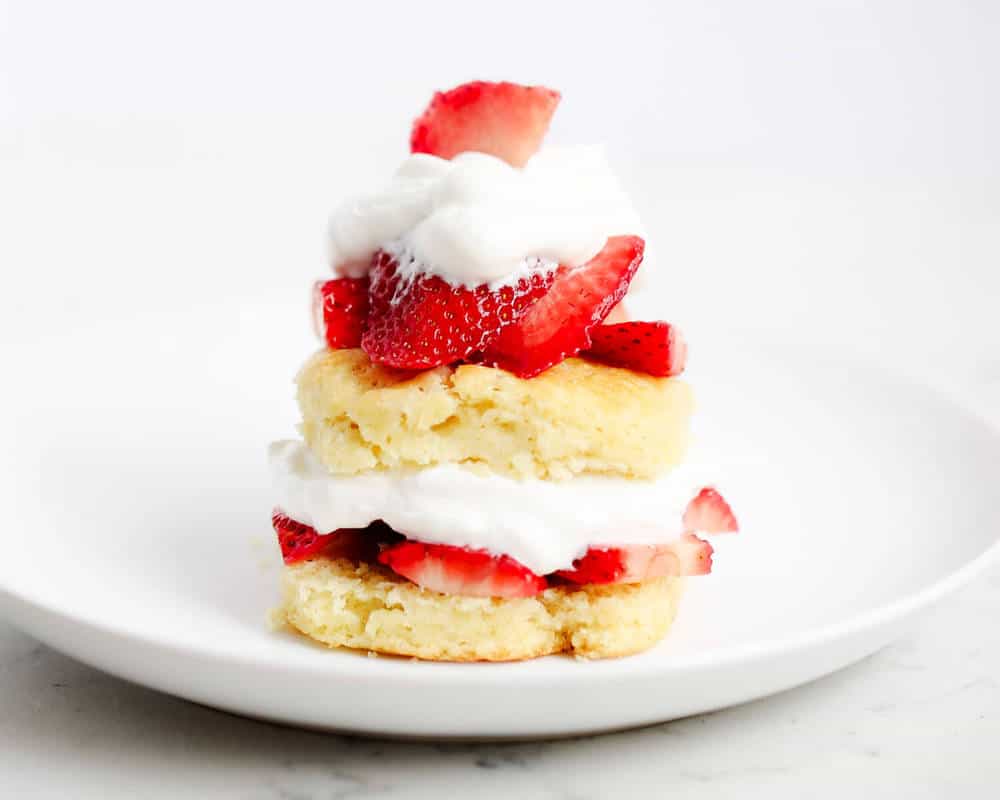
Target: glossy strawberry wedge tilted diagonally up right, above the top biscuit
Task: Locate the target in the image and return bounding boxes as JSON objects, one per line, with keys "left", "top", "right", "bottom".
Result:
{"left": 483, "top": 236, "right": 645, "bottom": 378}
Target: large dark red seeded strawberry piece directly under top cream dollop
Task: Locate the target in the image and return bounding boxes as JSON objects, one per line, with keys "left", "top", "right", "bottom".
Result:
{"left": 361, "top": 252, "right": 553, "bottom": 369}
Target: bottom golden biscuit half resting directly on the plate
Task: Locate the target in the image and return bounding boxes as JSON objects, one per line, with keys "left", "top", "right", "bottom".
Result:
{"left": 277, "top": 559, "right": 684, "bottom": 661}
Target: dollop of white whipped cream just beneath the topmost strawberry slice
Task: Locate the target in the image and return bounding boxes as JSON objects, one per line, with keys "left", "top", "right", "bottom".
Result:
{"left": 330, "top": 147, "right": 643, "bottom": 287}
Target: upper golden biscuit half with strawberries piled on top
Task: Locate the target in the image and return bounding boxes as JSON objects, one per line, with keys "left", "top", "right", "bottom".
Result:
{"left": 298, "top": 349, "right": 692, "bottom": 480}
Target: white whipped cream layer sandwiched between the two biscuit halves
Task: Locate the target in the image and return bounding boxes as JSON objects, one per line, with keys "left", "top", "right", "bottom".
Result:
{"left": 268, "top": 441, "right": 710, "bottom": 575}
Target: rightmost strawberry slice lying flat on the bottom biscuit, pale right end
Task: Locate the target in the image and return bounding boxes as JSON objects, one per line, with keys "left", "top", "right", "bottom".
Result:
{"left": 556, "top": 533, "right": 712, "bottom": 584}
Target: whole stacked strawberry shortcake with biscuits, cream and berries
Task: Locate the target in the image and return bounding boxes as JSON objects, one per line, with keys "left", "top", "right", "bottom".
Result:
{"left": 270, "top": 82, "right": 737, "bottom": 661}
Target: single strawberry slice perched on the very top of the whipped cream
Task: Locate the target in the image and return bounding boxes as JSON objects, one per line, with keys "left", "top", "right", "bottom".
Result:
{"left": 410, "top": 81, "right": 559, "bottom": 167}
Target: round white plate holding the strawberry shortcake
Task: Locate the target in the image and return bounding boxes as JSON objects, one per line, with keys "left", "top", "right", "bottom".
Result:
{"left": 0, "top": 301, "right": 1000, "bottom": 737}
